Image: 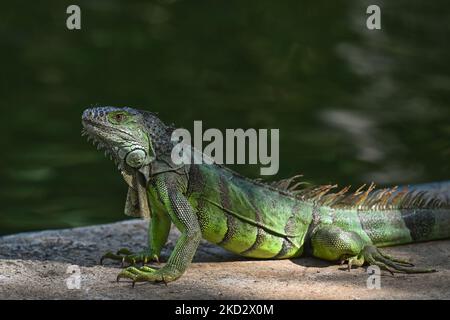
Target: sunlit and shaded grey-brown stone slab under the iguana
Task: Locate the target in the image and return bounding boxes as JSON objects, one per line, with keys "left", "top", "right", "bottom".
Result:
{"left": 0, "top": 220, "right": 450, "bottom": 299}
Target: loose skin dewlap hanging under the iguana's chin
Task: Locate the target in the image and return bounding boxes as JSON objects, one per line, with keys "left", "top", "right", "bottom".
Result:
{"left": 122, "top": 170, "right": 151, "bottom": 218}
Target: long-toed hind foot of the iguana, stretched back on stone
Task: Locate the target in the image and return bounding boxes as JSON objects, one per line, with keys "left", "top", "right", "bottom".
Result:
{"left": 341, "top": 245, "right": 436, "bottom": 275}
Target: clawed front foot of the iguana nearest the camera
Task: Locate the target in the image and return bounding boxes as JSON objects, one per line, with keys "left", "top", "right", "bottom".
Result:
{"left": 117, "top": 266, "right": 178, "bottom": 287}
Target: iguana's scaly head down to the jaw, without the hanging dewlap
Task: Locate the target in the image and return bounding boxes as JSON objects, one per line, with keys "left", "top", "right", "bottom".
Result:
{"left": 82, "top": 107, "right": 171, "bottom": 170}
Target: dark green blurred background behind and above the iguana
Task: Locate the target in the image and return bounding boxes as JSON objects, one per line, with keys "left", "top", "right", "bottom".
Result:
{"left": 0, "top": 0, "right": 450, "bottom": 234}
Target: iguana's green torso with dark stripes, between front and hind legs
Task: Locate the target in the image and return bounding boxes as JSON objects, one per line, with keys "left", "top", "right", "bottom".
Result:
{"left": 155, "top": 165, "right": 312, "bottom": 258}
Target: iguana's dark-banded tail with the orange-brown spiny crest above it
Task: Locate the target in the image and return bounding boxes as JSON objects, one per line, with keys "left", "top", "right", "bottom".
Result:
{"left": 271, "top": 176, "right": 450, "bottom": 246}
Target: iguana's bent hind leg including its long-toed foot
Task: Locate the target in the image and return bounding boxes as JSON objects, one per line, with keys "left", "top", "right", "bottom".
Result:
{"left": 311, "top": 225, "right": 435, "bottom": 273}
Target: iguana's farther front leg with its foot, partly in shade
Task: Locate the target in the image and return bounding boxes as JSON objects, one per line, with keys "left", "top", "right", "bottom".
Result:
{"left": 100, "top": 204, "right": 171, "bottom": 265}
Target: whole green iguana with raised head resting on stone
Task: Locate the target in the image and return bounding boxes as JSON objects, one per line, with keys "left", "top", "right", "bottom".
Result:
{"left": 82, "top": 107, "right": 450, "bottom": 285}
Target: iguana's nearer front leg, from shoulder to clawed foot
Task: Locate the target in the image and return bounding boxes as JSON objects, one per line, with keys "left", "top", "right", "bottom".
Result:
{"left": 117, "top": 176, "right": 201, "bottom": 285}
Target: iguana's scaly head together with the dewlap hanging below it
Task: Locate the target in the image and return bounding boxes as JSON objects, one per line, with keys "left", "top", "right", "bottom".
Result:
{"left": 82, "top": 107, "right": 171, "bottom": 217}
